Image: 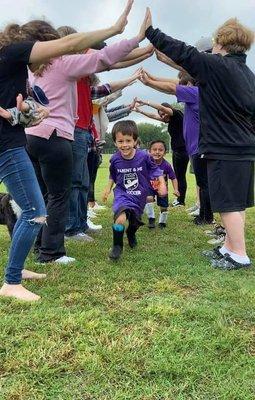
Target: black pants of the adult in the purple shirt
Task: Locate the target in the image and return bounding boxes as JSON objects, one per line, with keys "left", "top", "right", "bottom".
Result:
{"left": 192, "top": 154, "right": 213, "bottom": 223}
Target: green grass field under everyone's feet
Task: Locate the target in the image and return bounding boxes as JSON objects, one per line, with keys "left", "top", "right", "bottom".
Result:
{"left": 0, "top": 156, "right": 255, "bottom": 400}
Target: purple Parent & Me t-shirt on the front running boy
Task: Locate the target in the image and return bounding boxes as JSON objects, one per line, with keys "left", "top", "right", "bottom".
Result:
{"left": 110, "top": 149, "right": 163, "bottom": 216}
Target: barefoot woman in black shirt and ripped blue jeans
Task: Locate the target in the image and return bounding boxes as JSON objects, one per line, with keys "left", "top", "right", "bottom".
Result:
{"left": 0, "top": 0, "right": 144, "bottom": 301}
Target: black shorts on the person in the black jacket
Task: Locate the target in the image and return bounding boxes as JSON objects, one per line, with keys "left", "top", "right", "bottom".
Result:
{"left": 207, "top": 159, "right": 254, "bottom": 213}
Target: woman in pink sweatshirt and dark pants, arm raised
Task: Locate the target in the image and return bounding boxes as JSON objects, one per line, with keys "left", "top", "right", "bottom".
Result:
{"left": 26, "top": 14, "right": 148, "bottom": 264}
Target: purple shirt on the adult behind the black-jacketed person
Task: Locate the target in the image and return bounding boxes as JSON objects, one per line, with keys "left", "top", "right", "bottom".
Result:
{"left": 176, "top": 85, "right": 200, "bottom": 156}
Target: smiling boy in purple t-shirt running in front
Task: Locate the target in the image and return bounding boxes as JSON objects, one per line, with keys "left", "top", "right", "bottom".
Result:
{"left": 103, "top": 120, "right": 167, "bottom": 260}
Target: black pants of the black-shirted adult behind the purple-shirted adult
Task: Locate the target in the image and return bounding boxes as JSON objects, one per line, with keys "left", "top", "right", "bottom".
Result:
{"left": 173, "top": 151, "right": 189, "bottom": 205}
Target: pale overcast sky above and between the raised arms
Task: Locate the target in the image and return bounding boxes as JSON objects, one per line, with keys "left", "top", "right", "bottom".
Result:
{"left": 0, "top": 0, "right": 255, "bottom": 122}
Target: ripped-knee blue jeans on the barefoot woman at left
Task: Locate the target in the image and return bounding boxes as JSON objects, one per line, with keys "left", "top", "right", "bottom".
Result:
{"left": 0, "top": 147, "right": 46, "bottom": 284}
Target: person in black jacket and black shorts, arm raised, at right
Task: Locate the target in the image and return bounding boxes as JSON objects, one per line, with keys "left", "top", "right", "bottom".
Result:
{"left": 146, "top": 10, "right": 255, "bottom": 269}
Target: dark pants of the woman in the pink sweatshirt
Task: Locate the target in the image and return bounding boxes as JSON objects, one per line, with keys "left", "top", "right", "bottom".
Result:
{"left": 27, "top": 132, "right": 73, "bottom": 262}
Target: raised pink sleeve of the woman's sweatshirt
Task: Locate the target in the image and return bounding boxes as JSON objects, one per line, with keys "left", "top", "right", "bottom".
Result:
{"left": 62, "top": 37, "right": 139, "bottom": 80}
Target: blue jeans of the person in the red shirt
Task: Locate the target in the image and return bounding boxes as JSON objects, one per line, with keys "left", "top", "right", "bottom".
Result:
{"left": 66, "top": 128, "right": 92, "bottom": 236}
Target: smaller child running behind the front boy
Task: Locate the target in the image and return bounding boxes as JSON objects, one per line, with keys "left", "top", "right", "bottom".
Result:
{"left": 145, "top": 140, "right": 180, "bottom": 229}
